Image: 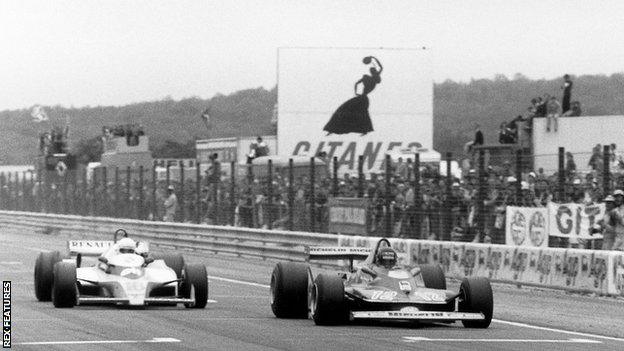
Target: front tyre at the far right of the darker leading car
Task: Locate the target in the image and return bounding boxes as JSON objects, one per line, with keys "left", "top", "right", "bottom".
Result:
{"left": 459, "top": 277, "right": 494, "bottom": 328}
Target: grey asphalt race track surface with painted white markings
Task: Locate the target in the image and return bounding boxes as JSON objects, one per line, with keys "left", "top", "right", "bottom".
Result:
{"left": 0, "top": 230, "right": 624, "bottom": 351}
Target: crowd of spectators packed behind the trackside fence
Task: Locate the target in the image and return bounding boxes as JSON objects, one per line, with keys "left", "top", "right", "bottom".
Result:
{"left": 0, "top": 145, "right": 624, "bottom": 250}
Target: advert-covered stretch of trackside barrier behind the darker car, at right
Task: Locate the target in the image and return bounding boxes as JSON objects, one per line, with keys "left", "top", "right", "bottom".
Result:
{"left": 338, "top": 235, "right": 624, "bottom": 296}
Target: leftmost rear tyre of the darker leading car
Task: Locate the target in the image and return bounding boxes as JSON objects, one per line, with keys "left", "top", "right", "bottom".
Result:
{"left": 271, "top": 262, "right": 312, "bottom": 318}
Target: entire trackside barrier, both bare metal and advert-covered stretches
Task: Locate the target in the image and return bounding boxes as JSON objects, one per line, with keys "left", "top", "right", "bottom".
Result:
{"left": 0, "top": 211, "right": 624, "bottom": 296}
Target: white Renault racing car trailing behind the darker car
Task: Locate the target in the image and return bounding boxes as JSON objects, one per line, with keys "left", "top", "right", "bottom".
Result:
{"left": 35, "top": 229, "right": 208, "bottom": 308}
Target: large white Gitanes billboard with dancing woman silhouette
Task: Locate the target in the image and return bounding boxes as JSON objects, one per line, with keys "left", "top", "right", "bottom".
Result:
{"left": 277, "top": 48, "right": 433, "bottom": 173}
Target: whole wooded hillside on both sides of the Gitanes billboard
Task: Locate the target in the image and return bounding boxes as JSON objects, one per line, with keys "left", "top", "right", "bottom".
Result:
{"left": 0, "top": 74, "right": 624, "bottom": 164}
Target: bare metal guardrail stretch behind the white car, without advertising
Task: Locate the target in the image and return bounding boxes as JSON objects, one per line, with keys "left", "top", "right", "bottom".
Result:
{"left": 0, "top": 211, "right": 338, "bottom": 261}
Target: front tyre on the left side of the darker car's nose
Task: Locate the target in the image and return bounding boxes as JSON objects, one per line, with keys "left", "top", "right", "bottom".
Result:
{"left": 310, "top": 274, "right": 348, "bottom": 325}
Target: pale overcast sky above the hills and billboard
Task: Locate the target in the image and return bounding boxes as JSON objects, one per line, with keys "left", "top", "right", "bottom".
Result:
{"left": 0, "top": 0, "right": 624, "bottom": 110}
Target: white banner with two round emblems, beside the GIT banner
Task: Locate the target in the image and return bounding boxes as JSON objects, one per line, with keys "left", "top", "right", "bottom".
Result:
{"left": 505, "top": 206, "right": 548, "bottom": 247}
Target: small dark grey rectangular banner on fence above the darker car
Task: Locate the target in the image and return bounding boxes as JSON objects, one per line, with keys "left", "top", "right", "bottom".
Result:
{"left": 328, "top": 197, "right": 368, "bottom": 235}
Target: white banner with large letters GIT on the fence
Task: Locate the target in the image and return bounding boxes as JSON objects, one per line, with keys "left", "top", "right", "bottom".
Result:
{"left": 548, "top": 203, "right": 605, "bottom": 241}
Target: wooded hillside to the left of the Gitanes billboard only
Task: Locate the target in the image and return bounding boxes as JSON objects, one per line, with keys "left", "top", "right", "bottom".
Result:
{"left": 0, "top": 88, "right": 277, "bottom": 164}
